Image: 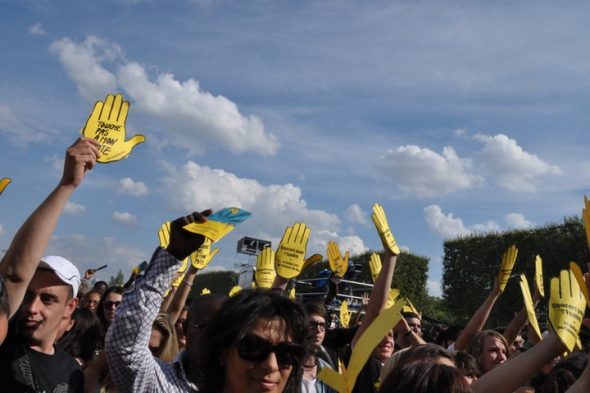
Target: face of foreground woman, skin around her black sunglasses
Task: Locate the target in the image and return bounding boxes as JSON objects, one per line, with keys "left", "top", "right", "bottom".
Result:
{"left": 222, "top": 319, "right": 293, "bottom": 393}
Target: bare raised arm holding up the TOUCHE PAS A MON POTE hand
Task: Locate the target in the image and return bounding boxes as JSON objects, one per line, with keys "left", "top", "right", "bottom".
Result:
{"left": 0, "top": 138, "right": 99, "bottom": 316}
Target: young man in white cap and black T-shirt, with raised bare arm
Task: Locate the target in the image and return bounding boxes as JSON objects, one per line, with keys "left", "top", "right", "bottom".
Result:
{"left": 0, "top": 138, "right": 99, "bottom": 393}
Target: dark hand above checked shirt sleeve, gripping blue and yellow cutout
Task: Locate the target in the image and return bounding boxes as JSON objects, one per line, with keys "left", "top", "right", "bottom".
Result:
{"left": 166, "top": 210, "right": 212, "bottom": 261}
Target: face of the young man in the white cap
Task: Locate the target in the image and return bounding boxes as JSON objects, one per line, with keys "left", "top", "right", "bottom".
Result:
{"left": 18, "top": 269, "right": 77, "bottom": 347}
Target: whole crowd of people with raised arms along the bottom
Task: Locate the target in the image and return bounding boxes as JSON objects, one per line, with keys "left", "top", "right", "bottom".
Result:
{"left": 0, "top": 138, "right": 590, "bottom": 393}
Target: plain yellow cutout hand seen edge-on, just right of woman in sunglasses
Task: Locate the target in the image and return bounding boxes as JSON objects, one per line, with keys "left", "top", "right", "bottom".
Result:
{"left": 318, "top": 299, "right": 405, "bottom": 393}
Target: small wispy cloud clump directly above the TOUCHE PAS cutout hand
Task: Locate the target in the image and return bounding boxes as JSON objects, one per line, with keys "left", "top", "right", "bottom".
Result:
{"left": 50, "top": 35, "right": 123, "bottom": 100}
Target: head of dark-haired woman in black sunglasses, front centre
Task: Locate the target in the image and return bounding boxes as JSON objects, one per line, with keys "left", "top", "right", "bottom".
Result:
{"left": 198, "top": 290, "right": 310, "bottom": 393}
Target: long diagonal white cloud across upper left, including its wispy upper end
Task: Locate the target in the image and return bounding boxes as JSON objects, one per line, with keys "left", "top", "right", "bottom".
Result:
{"left": 51, "top": 36, "right": 279, "bottom": 156}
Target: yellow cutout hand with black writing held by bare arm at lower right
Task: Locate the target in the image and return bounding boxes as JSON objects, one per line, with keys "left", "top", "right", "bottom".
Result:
{"left": 549, "top": 270, "right": 586, "bottom": 352}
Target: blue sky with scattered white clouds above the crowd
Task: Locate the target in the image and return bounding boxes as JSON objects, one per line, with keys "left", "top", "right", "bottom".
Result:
{"left": 0, "top": 0, "right": 590, "bottom": 295}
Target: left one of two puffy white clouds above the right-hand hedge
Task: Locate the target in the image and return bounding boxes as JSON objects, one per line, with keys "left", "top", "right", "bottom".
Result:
{"left": 381, "top": 145, "right": 481, "bottom": 197}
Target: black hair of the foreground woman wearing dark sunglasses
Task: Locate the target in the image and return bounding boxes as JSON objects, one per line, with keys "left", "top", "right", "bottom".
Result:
{"left": 196, "top": 290, "right": 311, "bottom": 393}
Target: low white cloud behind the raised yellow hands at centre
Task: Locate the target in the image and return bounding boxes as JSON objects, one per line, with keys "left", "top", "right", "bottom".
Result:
{"left": 163, "top": 161, "right": 366, "bottom": 255}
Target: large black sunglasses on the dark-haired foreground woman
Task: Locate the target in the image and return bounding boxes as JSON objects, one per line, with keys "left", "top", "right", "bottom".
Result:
{"left": 237, "top": 334, "right": 304, "bottom": 366}
